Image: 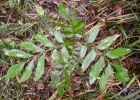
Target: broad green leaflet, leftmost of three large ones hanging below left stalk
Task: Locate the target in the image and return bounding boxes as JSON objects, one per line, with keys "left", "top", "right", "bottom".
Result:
{"left": 6, "top": 62, "right": 25, "bottom": 79}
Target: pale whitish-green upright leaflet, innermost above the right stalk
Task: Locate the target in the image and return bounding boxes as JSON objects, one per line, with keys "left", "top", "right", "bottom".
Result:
{"left": 88, "top": 27, "right": 100, "bottom": 43}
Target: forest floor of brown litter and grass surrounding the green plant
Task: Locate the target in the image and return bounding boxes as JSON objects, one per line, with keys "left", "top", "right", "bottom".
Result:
{"left": 0, "top": 0, "right": 140, "bottom": 100}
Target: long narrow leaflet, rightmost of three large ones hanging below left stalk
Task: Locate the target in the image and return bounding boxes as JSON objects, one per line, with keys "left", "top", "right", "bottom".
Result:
{"left": 35, "top": 54, "right": 45, "bottom": 81}
